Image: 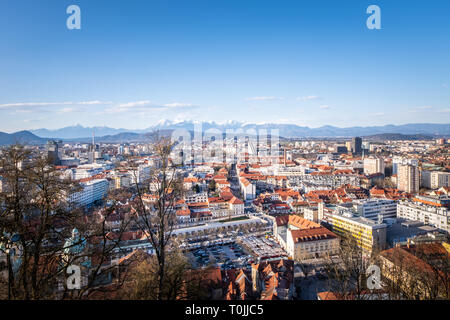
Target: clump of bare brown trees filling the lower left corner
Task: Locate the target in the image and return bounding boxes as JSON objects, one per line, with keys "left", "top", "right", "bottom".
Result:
{"left": 0, "top": 145, "right": 132, "bottom": 299}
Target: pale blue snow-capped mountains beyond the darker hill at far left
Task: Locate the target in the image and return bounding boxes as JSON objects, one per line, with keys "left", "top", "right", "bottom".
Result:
{"left": 31, "top": 120, "right": 450, "bottom": 141}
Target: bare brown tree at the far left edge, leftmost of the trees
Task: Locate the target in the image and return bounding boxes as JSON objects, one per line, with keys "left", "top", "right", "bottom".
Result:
{"left": 0, "top": 145, "right": 79, "bottom": 299}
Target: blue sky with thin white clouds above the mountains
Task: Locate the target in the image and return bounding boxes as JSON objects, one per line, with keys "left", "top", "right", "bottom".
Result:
{"left": 0, "top": 0, "right": 450, "bottom": 132}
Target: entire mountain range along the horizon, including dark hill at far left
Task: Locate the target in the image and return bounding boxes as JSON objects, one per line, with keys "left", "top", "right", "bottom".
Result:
{"left": 0, "top": 120, "right": 450, "bottom": 145}
